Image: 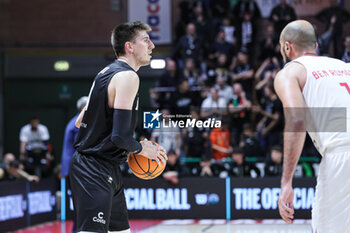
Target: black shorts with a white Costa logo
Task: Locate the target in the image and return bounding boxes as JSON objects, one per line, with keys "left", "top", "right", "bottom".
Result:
{"left": 69, "top": 152, "right": 130, "bottom": 233}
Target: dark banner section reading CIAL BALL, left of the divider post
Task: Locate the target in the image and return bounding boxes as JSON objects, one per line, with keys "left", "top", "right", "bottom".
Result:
{"left": 123, "top": 177, "right": 226, "bottom": 219}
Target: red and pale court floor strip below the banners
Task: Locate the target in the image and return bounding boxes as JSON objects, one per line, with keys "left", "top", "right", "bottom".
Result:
{"left": 15, "top": 219, "right": 312, "bottom": 233}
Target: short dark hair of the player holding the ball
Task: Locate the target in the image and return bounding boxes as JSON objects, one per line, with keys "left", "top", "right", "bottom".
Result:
{"left": 111, "top": 21, "right": 151, "bottom": 57}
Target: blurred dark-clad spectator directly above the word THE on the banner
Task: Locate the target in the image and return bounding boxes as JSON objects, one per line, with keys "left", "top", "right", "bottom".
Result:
{"left": 224, "top": 147, "right": 260, "bottom": 178}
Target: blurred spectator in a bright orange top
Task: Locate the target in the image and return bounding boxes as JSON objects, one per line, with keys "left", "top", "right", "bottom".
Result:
{"left": 209, "top": 121, "right": 232, "bottom": 160}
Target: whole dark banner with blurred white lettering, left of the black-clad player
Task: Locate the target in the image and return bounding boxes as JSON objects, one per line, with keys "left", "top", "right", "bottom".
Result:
{"left": 0, "top": 178, "right": 57, "bottom": 232}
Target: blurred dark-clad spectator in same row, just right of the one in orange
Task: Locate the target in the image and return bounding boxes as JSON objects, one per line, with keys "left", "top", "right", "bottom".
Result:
{"left": 239, "top": 123, "right": 262, "bottom": 157}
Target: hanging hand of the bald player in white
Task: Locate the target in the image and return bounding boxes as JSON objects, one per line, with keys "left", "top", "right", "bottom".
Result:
{"left": 278, "top": 184, "right": 294, "bottom": 224}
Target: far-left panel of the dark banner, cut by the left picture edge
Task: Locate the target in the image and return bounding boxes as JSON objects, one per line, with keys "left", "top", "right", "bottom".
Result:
{"left": 0, "top": 180, "right": 29, "bottom": 232}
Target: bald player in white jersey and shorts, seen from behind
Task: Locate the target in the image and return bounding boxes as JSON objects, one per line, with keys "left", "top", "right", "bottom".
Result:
{"left": 274, "top": 20, "right": 350, "bottom": 233}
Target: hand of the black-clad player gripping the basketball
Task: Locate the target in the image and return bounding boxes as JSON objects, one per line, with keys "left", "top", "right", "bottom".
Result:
{"left": 140, "top": 139, "right": 168, "bottom": 166}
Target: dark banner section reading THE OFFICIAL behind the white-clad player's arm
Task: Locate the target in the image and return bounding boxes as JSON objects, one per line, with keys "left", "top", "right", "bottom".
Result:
{"left": 230, "top": 177, "right": 316, "bottom": 219}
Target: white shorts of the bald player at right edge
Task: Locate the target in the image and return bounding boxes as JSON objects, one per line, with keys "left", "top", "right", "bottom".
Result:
{"left": 312, "top": 150, "right": 350, "bottom": 233}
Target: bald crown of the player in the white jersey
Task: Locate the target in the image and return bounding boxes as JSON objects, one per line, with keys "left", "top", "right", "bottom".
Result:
{"left": 280, "top": 20, "right": 317, "bottom": 50}
